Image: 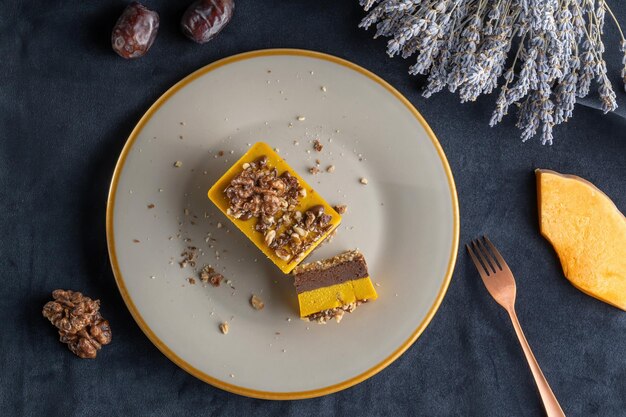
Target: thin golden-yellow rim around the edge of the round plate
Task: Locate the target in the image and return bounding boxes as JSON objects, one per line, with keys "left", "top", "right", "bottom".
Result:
{"left": 106, "top": 49, "right": 459, "bottom": 400}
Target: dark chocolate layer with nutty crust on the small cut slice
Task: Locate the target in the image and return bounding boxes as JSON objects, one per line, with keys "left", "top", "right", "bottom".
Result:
{"left": 293, "top": 251, "right": 368, "bottom": 294}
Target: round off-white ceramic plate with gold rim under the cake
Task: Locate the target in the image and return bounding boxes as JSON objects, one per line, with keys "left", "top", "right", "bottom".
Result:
{"left": 107, "top": 50, "right": 459, "bottom": 399}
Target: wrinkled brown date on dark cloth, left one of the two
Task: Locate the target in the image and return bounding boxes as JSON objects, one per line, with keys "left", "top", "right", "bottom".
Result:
{"left": 111, "top": 2, "right": 159, "bottom": 59}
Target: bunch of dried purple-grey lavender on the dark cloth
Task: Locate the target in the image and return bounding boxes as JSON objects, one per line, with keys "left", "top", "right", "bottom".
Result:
{"left": 359, "top": 0, "right": 626, "bottom": 144}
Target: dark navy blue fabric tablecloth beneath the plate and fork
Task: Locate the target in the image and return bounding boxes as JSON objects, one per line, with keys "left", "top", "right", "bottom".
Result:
{"left": 0, "top": 0, "right": 626, "bottom": 417}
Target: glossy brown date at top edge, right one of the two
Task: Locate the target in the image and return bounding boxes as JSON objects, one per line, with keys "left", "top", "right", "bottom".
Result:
{"left": 180, "top": 0, "right": 235, "bottom": 43}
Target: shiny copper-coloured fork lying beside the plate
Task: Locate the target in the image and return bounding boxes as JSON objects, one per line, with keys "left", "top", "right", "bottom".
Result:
{"left": 465, "top": 236, "right": 565, "bottom": 417}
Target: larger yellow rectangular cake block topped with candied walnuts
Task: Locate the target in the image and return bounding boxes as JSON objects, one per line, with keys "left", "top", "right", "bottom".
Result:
{"left": 208, "top": 142, "right": 341, "bottom": 274}
